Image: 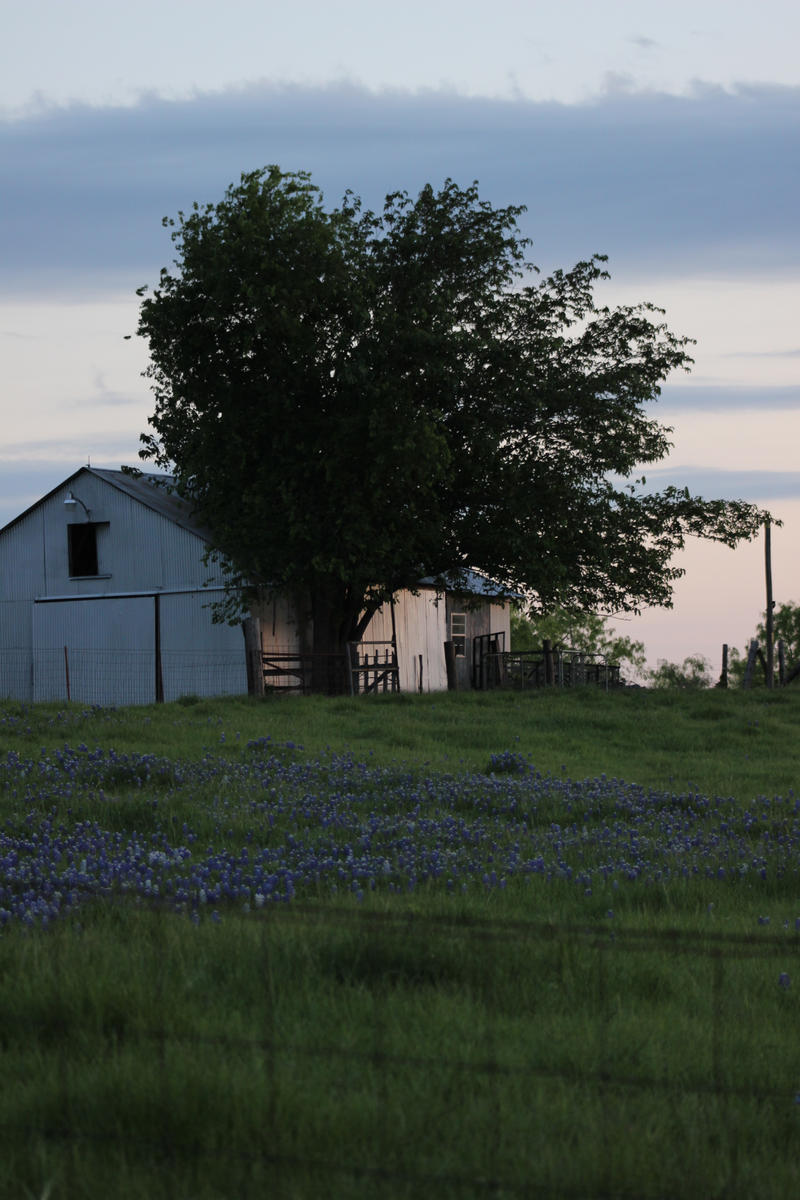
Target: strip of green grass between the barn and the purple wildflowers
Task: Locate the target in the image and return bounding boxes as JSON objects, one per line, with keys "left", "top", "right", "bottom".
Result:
{"left": 0, "top": 689, "right": 800, "bottom": 799}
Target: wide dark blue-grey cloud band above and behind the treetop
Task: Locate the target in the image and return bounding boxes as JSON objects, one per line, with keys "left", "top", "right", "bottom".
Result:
{"left": 0, "top": 84, "right": 800, "bottom": 294}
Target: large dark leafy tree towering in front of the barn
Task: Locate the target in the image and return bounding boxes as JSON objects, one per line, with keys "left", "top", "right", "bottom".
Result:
{"left": 138, "top": 167, "right": 763, "bottom": 652}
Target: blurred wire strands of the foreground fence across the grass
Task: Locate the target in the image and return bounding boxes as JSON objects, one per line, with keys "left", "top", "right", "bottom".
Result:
{"left": 0, "top": 899, "right": 800, "bottom": 1200}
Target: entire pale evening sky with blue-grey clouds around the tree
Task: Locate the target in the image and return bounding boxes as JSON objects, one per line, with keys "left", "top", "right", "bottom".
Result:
{"left": 0, "top": 0, "right": 800, "bottom": 667}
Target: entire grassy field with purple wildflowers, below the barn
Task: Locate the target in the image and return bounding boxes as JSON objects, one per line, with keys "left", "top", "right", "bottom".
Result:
{"left": 0, "top": 691, "right": 800, "bottom": 1200}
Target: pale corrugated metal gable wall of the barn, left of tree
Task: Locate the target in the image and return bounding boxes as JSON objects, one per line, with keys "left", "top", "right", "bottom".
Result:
{"left": 0, "top": 470, "right": 246, "bottom": 704}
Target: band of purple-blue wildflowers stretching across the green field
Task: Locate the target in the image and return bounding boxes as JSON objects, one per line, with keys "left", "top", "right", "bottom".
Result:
{"left": 0, "top": 737, "right": 800, "bottom": 928}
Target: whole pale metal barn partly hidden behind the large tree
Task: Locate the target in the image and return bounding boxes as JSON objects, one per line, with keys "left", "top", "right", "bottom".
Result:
{"left": 0, "top": 467, "right": 510, "bottom": 704}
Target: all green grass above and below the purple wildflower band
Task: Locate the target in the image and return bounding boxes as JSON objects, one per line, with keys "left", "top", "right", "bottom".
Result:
{"left": 0, "top": 691, "right": 800, "bottom": 1200}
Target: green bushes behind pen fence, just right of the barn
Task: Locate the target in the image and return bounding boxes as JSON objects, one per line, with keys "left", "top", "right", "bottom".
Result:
{"left": 511, "top": 607, "right": 646, "bottom": 674}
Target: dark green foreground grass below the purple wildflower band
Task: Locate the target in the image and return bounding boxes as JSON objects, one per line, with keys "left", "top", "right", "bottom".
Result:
{"left": 0, "top": 906, "right": 800, "bottom": 1200}
